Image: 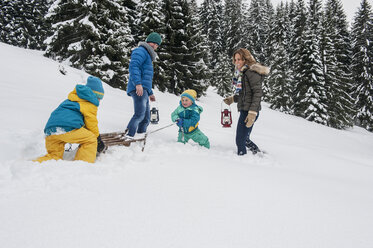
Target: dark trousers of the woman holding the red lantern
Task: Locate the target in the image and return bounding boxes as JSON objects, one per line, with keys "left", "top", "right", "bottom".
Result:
{"left": 236, "top": 111, "right": 259, "bottom": 155}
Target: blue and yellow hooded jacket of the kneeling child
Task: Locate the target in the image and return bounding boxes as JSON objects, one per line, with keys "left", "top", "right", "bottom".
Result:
{"left": 44, "top": 85, "right": 100, "bottom": 137}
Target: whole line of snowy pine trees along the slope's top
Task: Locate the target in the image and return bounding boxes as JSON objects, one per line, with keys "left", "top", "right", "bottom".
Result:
{"left": 0, "top": 0, "right": 373, "bottom": 131}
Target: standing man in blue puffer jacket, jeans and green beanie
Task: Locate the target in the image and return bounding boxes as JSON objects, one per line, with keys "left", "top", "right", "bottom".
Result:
{"left": 125, "top": 32, "right": 162, "bottom": 140}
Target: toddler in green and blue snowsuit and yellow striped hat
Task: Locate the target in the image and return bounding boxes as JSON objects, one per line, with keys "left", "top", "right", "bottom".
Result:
{"left": 171, "top": 90, "right": 210, "bottom": 148}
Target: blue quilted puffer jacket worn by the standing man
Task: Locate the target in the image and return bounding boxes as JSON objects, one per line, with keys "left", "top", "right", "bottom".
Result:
{"left": 127, "top": 42, "right": 156, "bottom": 96}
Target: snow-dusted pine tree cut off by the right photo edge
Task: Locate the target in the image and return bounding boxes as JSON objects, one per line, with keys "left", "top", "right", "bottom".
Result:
{"left": 351, "top": 0, "right": 373, "bottom": 131}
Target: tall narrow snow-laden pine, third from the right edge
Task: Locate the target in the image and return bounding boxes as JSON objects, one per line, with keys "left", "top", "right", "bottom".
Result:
{"left": 294, "top": 0, "right": 329, "bottom": 125}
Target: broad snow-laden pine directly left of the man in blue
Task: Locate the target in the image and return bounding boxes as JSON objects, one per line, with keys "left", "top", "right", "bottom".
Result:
{"left": 46, "top": 0, "right": 132, "bottom": 89}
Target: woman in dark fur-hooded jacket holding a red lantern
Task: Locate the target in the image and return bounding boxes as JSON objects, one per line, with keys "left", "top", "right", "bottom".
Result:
{"left": 224, "top": 48, "right": 269, "bottom": 155}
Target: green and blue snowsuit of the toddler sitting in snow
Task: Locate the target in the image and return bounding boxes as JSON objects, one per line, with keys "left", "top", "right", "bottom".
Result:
{"left": 171, "top": 102, "right": 210, "bottom": 148}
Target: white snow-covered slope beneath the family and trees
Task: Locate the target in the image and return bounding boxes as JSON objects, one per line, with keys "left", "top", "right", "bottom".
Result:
{"left": 0, "top": 43, "right": 373, "bottom": 248}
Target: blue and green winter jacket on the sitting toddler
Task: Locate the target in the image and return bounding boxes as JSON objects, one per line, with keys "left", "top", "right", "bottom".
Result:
{"left": 171, "top": 101, "right": 203, "bottom": 133}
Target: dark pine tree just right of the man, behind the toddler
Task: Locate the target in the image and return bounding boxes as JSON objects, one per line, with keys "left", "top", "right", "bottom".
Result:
{"left": 160, "top": 0, "right": 207, "bottom": 95}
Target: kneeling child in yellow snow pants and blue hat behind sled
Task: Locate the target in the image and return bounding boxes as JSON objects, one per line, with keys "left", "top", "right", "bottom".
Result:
{"left": 34, "top": 76, "right": 104, "bottom": 163}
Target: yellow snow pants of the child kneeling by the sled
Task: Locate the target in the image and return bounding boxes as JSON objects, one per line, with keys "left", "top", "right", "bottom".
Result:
{"left": 34, "top": 127, "right": 97, "bottom": 163}
